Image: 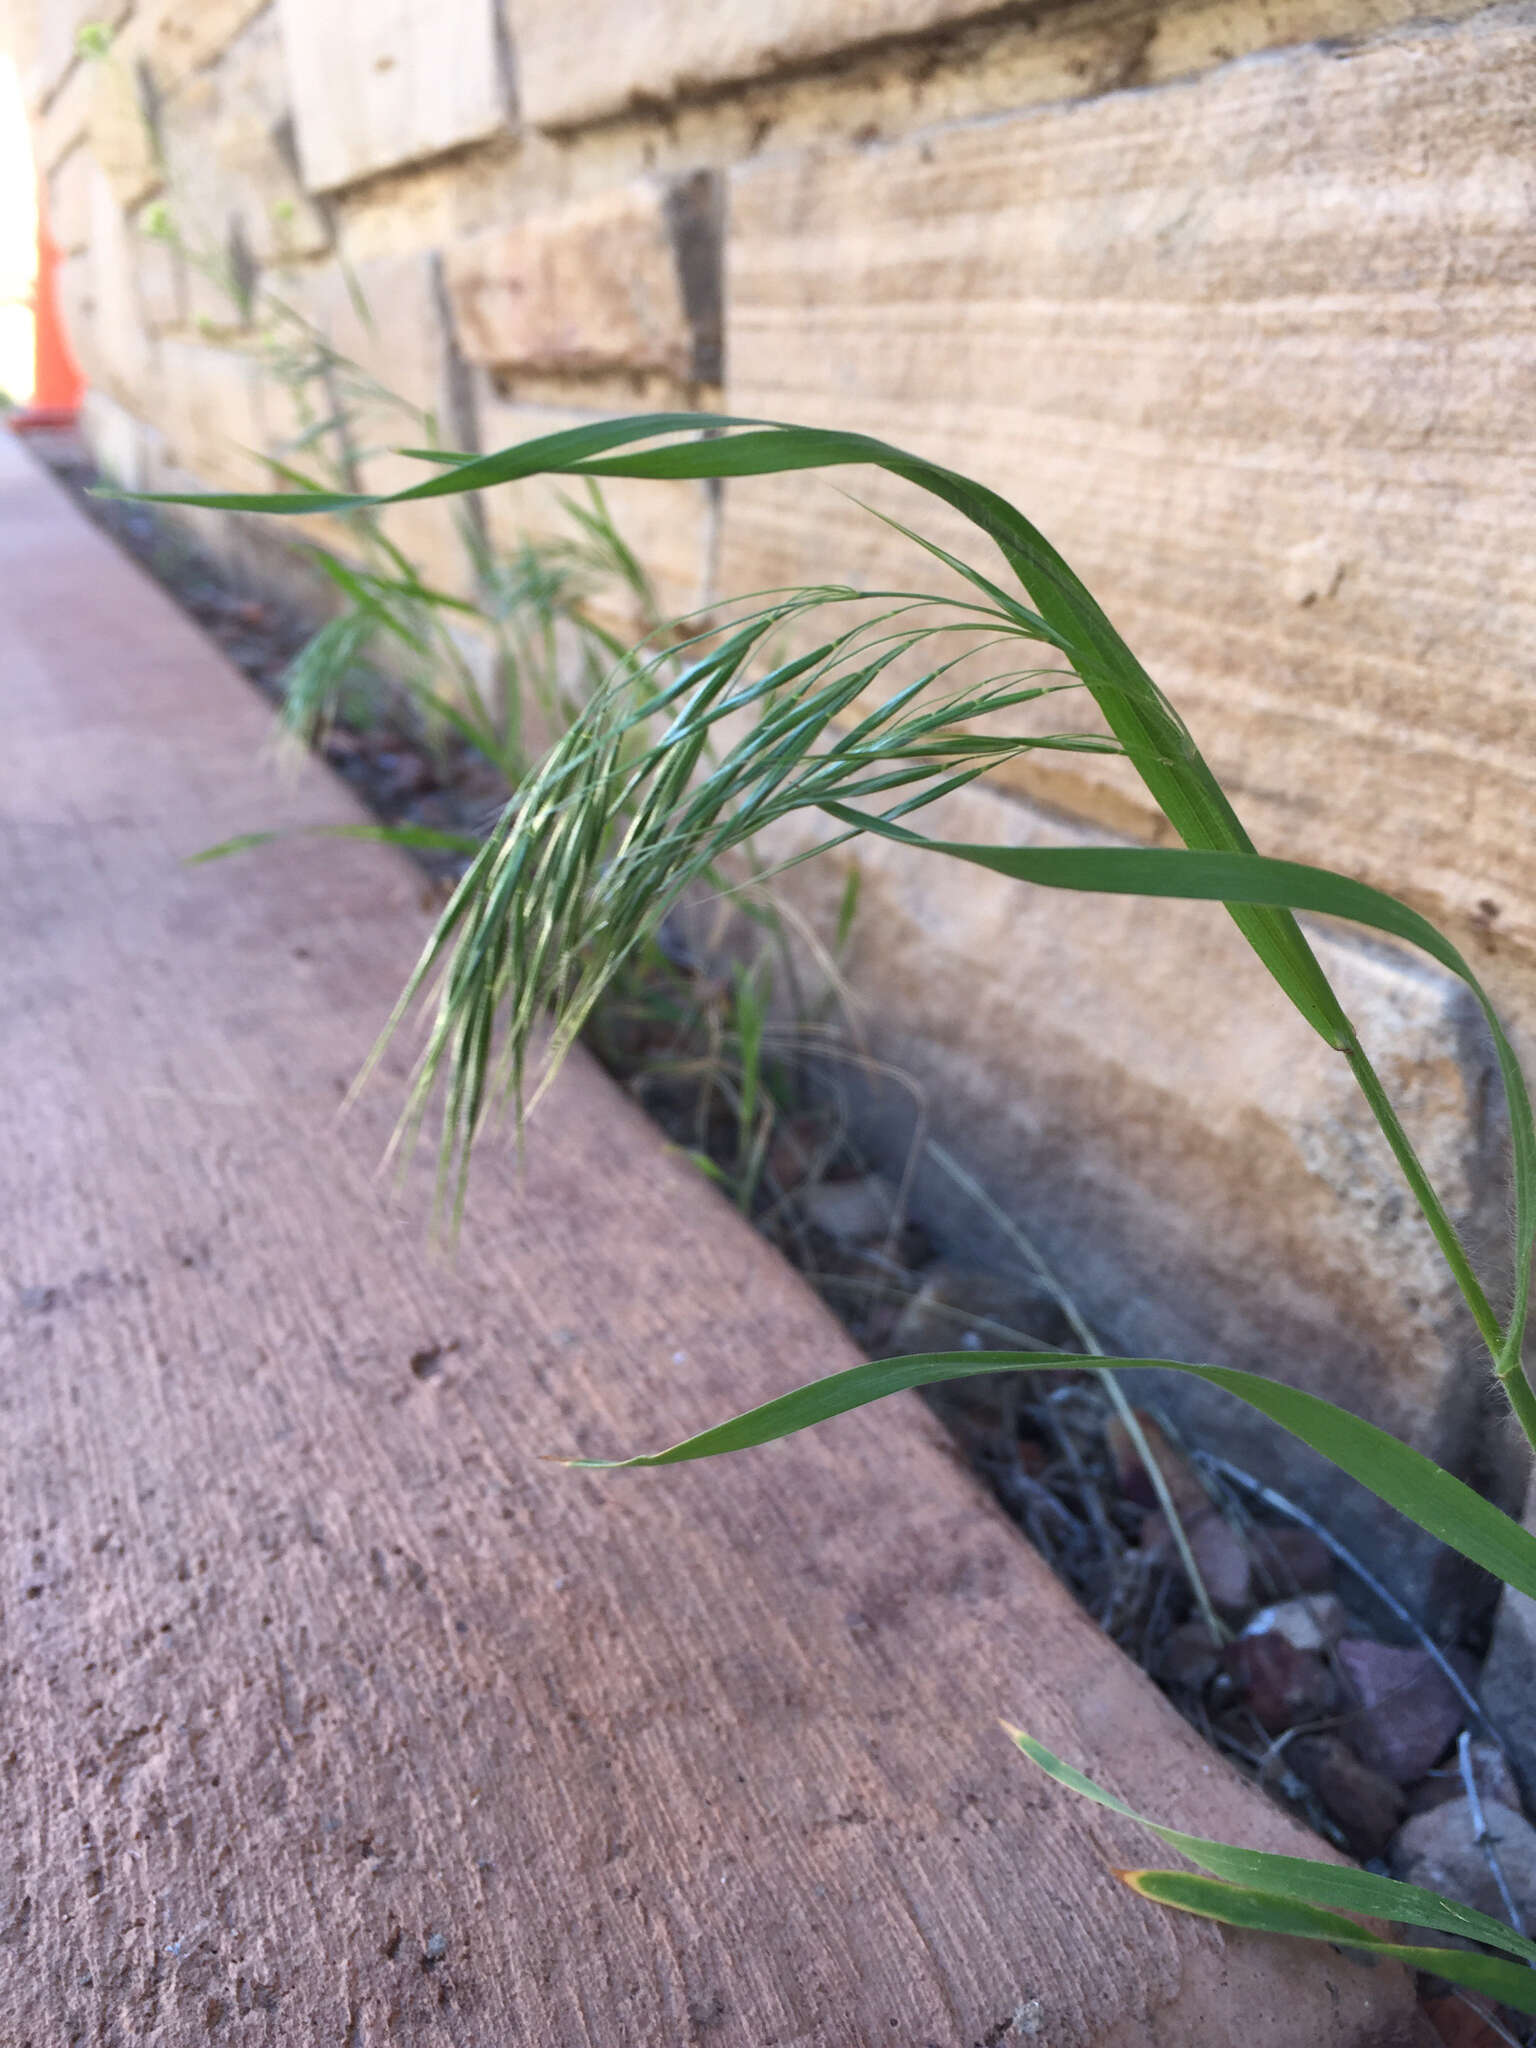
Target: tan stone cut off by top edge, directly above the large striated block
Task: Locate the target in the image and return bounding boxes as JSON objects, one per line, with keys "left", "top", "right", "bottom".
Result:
{"left": 510, "top": 0, "right": 987, "bottom": 127}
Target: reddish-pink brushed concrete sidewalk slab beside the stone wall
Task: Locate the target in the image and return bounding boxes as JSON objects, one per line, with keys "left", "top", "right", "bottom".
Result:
{"left": 0, "top": 434, "right": 1423, "bottom": 2048}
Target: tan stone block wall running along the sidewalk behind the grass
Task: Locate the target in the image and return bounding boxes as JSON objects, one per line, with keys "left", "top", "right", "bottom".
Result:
{"left": 0, "top": 0, "right": 1536, "bottom": 1597}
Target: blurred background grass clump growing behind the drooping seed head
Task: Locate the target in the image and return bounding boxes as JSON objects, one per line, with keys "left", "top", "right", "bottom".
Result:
{"left": 131, "top": 203, "right": 856, "bottom": 1245}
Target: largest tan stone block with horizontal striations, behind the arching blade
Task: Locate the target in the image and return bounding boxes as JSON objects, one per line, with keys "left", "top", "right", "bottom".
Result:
{"left": 723, "top": 10, "right": 1536, "bottom": 987}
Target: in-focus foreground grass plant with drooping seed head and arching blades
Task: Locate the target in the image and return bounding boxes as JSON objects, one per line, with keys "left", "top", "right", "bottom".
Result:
{"left": 138, "top": 414, "right": 1536, "bottom": 2013}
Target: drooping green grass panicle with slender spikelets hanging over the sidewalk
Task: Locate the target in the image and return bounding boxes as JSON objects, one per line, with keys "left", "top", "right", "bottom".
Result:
{"left": 382, "top": 590, "right": 1116, "bottom": 1196}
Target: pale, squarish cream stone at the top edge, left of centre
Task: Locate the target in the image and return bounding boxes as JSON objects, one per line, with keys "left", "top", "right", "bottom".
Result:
{"left": 279, "top": 0, "right": 510, "bottom": 193}
